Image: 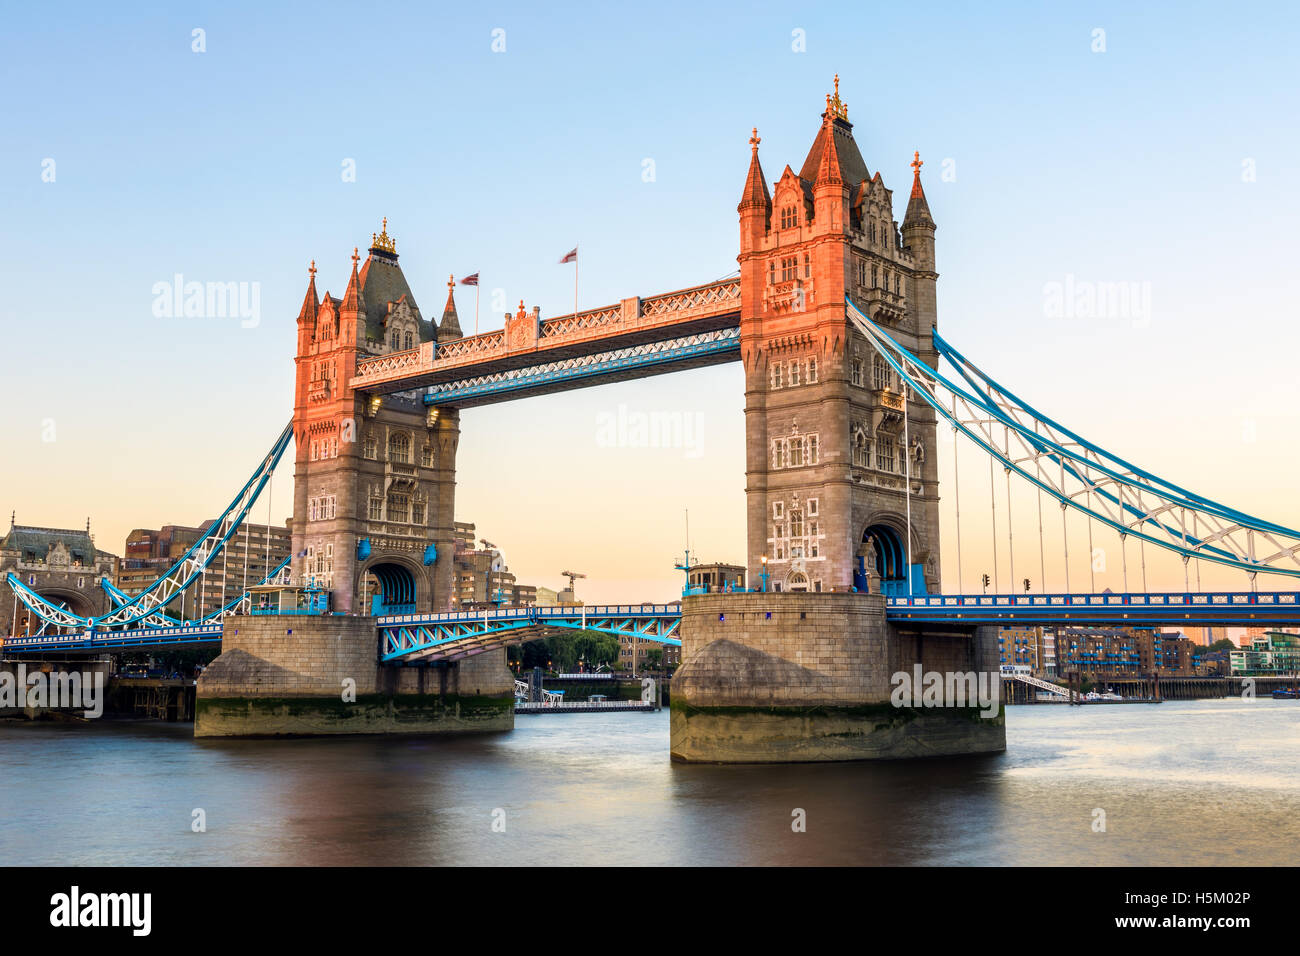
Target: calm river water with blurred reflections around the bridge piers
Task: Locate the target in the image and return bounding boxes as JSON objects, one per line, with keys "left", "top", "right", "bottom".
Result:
{"left": 0, "top": 700, "right": 1300, "bottom": 865}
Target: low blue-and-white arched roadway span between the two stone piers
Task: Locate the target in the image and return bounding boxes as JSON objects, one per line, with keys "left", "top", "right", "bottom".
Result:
{"left": 378, "top": 605, "right": 681, "bottom": 662}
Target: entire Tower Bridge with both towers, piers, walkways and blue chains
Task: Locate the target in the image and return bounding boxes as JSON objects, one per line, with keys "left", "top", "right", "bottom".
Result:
{"left": 7, "top": 78, "right": 1300, "bottom": 761}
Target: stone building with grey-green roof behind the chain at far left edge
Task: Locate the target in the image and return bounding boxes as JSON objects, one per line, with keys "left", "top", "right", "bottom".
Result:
{"left": 0, "top": 516, "right": 117, "bottom": 635}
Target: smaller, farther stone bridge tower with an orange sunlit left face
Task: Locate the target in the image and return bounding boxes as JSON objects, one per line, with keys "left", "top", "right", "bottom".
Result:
{"left": 293, "top": 220, "right": 460, "bottom": 614}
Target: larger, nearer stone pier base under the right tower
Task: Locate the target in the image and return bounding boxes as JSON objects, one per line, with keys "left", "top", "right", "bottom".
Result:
{"left": 671, "top": 592, "right": 1006, "bottom": 763}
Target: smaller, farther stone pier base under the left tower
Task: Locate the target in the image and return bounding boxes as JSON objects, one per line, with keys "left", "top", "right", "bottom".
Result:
{"left": 194, "top": 615, "right": 515, "bottom": 737}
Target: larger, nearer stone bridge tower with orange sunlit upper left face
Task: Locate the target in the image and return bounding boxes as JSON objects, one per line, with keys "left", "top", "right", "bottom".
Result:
{"left": 737, "top": 77, "right": 940, "bottom": 594}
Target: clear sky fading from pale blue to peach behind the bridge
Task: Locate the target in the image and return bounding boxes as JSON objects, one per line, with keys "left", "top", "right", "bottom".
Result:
{"left": 0, "top": 3, "right": 1300, "bottom": 601}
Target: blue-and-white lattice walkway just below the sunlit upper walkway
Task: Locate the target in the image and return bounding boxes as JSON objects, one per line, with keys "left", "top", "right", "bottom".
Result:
{"left": 424, "top": 326, "right": 740, "bottom": 405}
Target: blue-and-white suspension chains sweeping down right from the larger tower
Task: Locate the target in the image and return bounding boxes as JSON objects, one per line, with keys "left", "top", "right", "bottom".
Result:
{"left": 846, "top": 300, "right": 1300, "bottom": 581}
